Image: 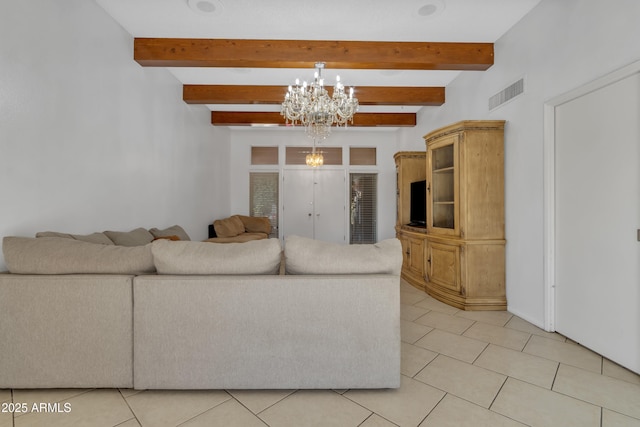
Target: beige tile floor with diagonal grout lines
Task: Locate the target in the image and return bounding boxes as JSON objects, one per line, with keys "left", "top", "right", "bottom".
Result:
{"left": 0, "top": 283, "right": 640, "bottom": 427}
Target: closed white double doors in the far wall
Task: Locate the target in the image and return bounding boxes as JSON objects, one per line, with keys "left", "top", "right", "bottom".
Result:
{"left": 282, "top": 168, "right": 346, "bottom": 243}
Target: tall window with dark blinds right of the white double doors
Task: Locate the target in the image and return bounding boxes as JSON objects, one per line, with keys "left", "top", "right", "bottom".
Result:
{"left": 349, "top": 173, "right": 378, "bottom": 244}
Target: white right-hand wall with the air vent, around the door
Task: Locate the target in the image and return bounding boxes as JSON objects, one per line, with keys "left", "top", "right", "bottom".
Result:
{"left": 400, "top": 0, "right": 640, "bottom": 326}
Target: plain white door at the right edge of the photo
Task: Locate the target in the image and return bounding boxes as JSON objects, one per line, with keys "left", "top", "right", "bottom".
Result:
{"left": 555, "top": 73, "right": 640, "bottom": 373}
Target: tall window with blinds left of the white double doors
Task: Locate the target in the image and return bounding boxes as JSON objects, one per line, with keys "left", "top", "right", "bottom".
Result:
{"left": 249, "top": 172, "right": 279, "bottom": 237}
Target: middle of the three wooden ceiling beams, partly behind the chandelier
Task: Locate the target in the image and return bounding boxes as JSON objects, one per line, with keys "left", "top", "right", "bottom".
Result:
{"left": 182, "top": 85, "right": 445, "bottom": 106}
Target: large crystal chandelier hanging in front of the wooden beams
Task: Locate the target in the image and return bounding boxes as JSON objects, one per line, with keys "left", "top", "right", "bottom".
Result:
{"left": 280, "top": 62, "right": 358, "bottom": 140}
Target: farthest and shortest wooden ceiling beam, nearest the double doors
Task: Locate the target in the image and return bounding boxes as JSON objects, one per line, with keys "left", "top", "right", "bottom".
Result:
{"left": 211, "top": 111, "right": 416, "bottom": 127}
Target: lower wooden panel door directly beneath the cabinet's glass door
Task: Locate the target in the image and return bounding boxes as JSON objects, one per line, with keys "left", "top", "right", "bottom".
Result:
{"left": 427, "top": 242, "right": 460, "bottom": 292}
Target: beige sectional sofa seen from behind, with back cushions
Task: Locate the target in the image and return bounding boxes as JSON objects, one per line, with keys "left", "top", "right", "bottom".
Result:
{"left": 0, "top": 236, "right": 402, "bottom": 389}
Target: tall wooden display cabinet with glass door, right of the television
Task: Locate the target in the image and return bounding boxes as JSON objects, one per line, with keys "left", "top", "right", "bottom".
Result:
{"left": 423, "top": 121, "right": 507, "bottom": 310}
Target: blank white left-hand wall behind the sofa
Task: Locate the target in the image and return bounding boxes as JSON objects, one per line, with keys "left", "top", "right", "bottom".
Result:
{"left": 0, "top": 0, "right": 229, "bottom": 270}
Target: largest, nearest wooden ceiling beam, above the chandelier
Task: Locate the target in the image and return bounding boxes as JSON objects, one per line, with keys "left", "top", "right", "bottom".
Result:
{"left": 133, "top": 38, "right": 494, "bottom": 70}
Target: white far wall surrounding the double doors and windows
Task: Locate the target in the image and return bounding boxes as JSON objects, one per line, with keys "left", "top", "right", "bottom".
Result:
{"left": 230, "top": 127, "right": 397, "bottom": 240}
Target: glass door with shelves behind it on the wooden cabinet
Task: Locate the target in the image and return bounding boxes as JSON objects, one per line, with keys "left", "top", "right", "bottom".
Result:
{"left": 431, "top": 144, "right": 455, "bottom": 229}
